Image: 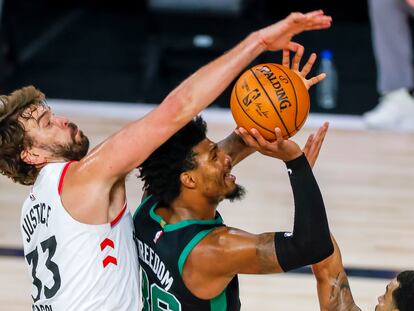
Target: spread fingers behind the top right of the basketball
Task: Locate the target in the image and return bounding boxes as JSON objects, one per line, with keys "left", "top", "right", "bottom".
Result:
{"left": 282, "top": 42, "right": 326, "bottom": 90}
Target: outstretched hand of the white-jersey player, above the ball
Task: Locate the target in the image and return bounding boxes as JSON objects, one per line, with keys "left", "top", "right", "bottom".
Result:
{"left": 258, "top": 10, "right": 332, "bottom": 51}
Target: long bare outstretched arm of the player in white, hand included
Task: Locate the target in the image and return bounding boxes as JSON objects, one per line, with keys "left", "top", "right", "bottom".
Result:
{"left": 84, "top": 11, "right": 331, "bottom": 184}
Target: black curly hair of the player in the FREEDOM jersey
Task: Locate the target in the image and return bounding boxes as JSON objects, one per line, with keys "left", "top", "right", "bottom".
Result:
{"left": 139, "top": 116, "right": 207, "bottom": 206}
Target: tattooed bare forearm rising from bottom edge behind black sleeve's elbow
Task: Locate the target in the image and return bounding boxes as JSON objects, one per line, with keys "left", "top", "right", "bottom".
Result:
{"left": 312, "top": 236, "right": 361, "bottom": 311}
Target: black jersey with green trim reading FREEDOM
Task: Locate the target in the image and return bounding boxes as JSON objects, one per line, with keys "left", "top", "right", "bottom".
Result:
{"left": 134, "top": 196, "right": 240, "bottom": 311}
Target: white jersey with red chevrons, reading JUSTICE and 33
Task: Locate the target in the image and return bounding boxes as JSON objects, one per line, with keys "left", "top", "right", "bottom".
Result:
{"left": 21, "top": 162, "right": 141, "bottom": 311}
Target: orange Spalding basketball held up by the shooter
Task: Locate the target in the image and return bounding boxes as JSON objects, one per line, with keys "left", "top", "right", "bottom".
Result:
{"left": 230, "top": 63, "right": 310, "bottom": 140}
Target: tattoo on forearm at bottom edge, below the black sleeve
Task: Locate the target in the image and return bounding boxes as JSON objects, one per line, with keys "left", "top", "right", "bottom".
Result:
{"left": 328, "top": 272, "right": 362, "bottom": 311}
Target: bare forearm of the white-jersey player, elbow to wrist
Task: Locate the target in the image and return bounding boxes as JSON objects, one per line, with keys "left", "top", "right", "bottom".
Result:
{"left": 126, "top": 32, "right": 265, "bottom": 152}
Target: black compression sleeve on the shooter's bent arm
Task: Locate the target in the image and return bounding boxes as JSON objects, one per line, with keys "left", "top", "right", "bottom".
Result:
{"left": 275, "top": 154, "right": 334, "bottom": 271}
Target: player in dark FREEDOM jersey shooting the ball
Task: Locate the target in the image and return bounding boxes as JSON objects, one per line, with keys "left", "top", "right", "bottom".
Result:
{"left": 134, "top": 47, "right": 333, "bottom": 311}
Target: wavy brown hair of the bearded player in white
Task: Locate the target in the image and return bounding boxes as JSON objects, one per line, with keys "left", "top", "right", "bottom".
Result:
{"left": 0, "top": 86, "right": 45, "bottom": 185}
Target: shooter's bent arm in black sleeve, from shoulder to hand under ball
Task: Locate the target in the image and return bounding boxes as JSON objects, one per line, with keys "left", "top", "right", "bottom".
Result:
{"left": 183, "top": 123, "right": 333, "bottom": 299}
